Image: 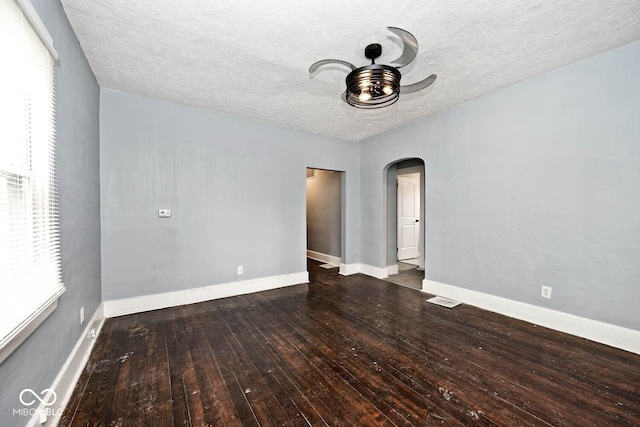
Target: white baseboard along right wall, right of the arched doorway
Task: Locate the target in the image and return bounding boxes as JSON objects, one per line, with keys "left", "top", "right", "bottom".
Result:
{"left": 422, "top": 279, "right": 640, "bottom": 354}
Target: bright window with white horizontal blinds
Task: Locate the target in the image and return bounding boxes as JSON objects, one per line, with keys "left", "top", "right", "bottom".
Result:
{"left": 0, "top": 0, "right": 65, "bottom": 362}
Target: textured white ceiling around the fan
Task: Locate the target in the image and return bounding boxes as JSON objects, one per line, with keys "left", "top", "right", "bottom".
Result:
{"left": 62, "top": 0, "right": 640, "bottom": 141}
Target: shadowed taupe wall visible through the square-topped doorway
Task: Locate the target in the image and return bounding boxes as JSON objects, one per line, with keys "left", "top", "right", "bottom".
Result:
{"left": 307, "top": 169, "right": 342, "bottom": 258}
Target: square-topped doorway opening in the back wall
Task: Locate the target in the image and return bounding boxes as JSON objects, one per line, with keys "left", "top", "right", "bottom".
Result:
{"left": 307, "top": 168, "right": 344, "bottom": 274}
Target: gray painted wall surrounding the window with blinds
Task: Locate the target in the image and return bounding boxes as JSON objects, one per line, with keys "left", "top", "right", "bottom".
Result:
{"left": 0, "top": 0, "right": 100, "bottom": 426}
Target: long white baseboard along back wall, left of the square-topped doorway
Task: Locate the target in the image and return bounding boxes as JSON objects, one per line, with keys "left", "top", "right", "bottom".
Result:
{"left": 103, "top": 271, "right": 309, "bottom": 318}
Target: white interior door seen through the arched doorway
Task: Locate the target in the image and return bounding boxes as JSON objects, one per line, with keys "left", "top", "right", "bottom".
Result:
{"left": 397, "top": 173, "right": 420, "bottom": 261}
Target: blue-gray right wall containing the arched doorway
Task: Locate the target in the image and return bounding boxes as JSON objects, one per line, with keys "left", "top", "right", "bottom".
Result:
{"left": 360, "top": 42, "right": 640, "bottom": 329}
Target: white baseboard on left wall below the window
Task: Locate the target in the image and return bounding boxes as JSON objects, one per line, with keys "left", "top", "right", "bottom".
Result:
{"left": 27, "top": 304, "right": 104, "bottom": 427}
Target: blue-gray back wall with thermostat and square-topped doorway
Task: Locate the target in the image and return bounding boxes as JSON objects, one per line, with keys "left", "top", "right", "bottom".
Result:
{"left": 100, "top": 89, "right": 360, "bottom": 301}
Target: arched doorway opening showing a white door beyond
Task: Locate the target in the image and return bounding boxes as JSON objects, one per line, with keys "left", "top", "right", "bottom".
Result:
{"left": 386, "top": 158, "right": 425, "bottom": 289}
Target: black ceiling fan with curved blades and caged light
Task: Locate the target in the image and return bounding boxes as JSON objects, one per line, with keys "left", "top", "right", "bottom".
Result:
{"left": 309, "top": 27, "right": 437, "bottom": 108}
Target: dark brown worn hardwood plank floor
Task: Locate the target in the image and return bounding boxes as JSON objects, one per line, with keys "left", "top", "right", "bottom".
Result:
{"left": 60, "top": 261, "right": 640, "bottom": 427}
